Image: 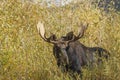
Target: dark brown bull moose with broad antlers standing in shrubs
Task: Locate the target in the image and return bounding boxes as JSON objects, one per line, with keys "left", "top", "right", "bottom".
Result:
{"left": 37, "top": 22, "right": 110, "bottom": 74}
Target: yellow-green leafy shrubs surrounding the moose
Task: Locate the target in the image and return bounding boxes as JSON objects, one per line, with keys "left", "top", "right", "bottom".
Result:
{"left": 0, "top": 0, "right": 120, "bottom": 80}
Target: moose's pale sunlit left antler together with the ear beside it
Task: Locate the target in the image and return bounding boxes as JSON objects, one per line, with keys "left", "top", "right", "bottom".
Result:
{"left": 37, "top": 22, "right": 57, "bottom": 44}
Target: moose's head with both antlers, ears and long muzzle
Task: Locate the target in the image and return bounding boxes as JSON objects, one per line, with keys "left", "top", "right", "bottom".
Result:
{"left": 37, "top": 22, "right": 88, "bottom": 64}
